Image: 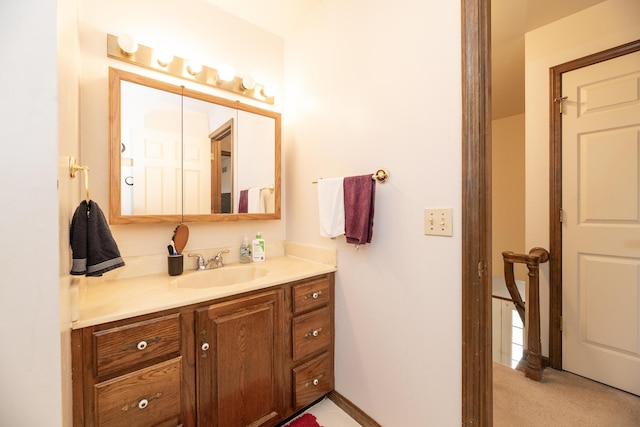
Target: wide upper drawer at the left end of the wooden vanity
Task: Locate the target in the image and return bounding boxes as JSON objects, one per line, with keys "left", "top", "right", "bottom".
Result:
{"left": 93, "top": 313, "right": 180, "bottom": 376}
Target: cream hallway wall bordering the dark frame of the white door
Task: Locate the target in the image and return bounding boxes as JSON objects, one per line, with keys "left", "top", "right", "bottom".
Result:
{"left": 525, "top": 0, "right": 640, "bottom": 354}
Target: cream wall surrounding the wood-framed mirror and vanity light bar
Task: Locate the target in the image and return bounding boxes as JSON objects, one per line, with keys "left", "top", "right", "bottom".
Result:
{"left": 79, "top": 0, "right": 285, "bottom": 261}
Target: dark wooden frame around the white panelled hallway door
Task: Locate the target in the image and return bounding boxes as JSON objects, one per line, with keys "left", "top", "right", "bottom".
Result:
{"left": 549, "top": 40, "right": 640, "bottom": 369}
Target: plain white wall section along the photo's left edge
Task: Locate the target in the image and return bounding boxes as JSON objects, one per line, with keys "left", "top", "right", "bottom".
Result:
{"left": 0, "top": 0, "right": 63, "bottom": 427}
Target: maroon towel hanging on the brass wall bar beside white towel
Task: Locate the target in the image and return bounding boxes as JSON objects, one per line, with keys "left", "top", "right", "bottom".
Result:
{"left": 344, "top": 174, "right": 376, "bottom": 245}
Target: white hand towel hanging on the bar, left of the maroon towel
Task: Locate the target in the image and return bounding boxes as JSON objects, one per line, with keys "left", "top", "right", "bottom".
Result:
{"left": 318, "top": 178, "right": 344, "bottom": 237}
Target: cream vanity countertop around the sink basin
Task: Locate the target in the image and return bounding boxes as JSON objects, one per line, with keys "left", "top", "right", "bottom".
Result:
{"left": 71, "top": 256, "right": 336, "bottom": 329}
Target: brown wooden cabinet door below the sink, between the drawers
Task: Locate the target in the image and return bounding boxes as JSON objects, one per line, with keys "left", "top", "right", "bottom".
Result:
{"left": 196, "top": 290, "right": 285, "bottom": 427}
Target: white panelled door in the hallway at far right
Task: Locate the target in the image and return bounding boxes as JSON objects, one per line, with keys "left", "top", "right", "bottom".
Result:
{"left": 562, "top": 52, "right": 640, "bottom": 395}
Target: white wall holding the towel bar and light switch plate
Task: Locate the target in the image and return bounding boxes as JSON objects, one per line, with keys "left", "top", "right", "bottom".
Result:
{"left": 283, "top": 0, "right": 461, "bottom": 427}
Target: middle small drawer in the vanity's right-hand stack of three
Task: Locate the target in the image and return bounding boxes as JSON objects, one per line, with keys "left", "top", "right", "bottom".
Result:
{"left": 293, "top": 307, "right": 333, "bottom": 362}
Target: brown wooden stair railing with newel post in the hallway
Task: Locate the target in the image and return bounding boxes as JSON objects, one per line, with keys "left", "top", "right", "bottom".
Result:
{"left": 502, "top": 247, "right": 549, "bottom": 381}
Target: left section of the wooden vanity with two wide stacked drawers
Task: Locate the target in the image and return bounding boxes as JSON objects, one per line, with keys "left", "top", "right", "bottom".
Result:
{"left": 71, "top": 312, "right": 194, "bottom": 427}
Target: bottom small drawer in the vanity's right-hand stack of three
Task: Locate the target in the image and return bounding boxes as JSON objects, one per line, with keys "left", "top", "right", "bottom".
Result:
{"left": 293, "top": 353, "right": 333, "bottom": 411}
